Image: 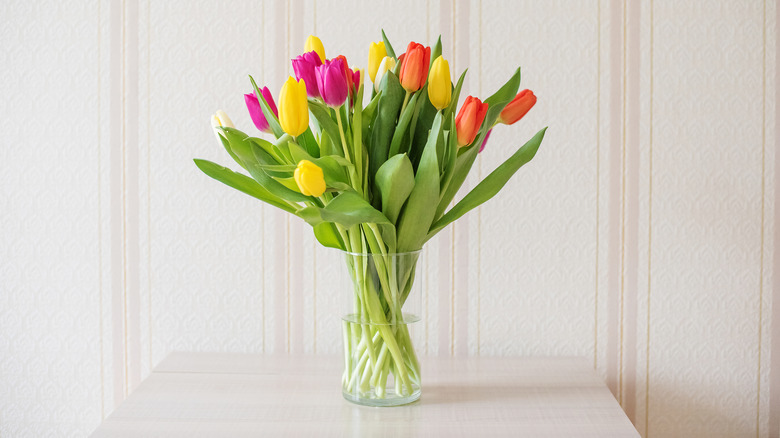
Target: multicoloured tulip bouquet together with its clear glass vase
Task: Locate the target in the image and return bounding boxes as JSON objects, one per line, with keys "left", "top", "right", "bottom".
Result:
{"left": 195, "top": 32, "right": 546, "bottom": 402}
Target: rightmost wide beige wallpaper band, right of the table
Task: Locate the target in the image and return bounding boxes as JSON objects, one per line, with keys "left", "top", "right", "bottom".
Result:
{"left": 647, "top": 0, "right": 765, "bottom": 437}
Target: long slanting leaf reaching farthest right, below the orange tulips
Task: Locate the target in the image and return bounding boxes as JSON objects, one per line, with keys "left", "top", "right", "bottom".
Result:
{"left": 428, "top": 128, "right": 547, "bottom": 239}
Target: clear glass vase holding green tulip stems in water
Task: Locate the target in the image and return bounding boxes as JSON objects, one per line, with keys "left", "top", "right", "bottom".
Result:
{"left": 340, "top": 251, "right": 423, "bottom": 406}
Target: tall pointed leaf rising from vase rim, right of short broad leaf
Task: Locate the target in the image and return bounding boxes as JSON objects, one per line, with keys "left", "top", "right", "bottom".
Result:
{"left": 398, "top": 113, "right": 442, "bottom": 252}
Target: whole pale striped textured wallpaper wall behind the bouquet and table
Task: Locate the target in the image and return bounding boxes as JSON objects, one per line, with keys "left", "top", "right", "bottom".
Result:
{"left": 0, "top": 0, "right": 780, "bottom": 437}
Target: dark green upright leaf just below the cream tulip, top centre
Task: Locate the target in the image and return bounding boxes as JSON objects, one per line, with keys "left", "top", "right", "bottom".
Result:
{"left": 368, "top": 72, "right": 406, "bottom": 180}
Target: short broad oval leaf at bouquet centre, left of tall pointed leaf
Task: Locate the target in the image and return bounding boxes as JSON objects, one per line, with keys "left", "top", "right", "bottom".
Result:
{"left": 374, "top": 154, "right": 414, "bottom": 223}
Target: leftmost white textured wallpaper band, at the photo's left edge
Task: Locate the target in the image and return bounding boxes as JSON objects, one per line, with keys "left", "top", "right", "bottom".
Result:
{"left": 0, "top": 1, "right": 105, "bottom": 437}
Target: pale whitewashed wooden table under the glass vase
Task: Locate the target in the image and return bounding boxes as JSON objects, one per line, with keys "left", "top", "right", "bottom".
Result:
{"left": 92, "top": 353, "right": 639, "bottom": 438}
